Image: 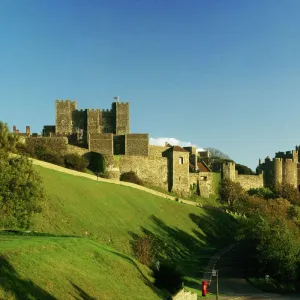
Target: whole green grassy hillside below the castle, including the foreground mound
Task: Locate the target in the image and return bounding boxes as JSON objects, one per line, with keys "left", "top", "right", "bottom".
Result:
{"left": 0, "top": 166, "right": 235, "bottom": 299}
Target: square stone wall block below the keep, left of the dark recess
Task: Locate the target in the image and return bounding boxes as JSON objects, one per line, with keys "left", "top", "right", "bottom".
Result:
{"left": 88, "top": 133, "right": 113, "bottom": 155}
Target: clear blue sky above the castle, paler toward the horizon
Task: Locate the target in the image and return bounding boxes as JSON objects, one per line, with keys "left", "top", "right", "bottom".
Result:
{"left": 0, "top": 0, "right": 300, "bottom": 168}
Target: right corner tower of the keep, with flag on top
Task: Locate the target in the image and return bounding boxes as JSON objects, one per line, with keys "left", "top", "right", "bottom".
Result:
{"left": 112, "top": 102, "right": 130, "bottom": 135}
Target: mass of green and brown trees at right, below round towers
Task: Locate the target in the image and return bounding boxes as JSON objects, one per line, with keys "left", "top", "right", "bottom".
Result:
{"left": 219, "top": 179, "right": 300, "bottom": 283}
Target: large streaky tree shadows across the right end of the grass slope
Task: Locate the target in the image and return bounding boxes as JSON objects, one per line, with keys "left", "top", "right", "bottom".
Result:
{"left": 129, "top": 208, "right": 237, "bottom": 289}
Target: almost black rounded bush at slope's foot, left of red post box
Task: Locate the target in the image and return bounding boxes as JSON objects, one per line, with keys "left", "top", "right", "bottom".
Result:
{"left": 153, "top": 263, "right": 183, "bottom": 295}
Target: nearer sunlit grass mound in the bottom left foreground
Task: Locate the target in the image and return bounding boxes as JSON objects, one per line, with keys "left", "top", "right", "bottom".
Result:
{"left": 0, "top": 236, "right": 160, "bottom": 300}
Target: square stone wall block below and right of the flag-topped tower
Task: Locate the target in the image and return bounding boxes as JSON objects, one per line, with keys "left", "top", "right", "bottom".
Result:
{"left": 125, "top": 134, "right": 149, "bottom": 156}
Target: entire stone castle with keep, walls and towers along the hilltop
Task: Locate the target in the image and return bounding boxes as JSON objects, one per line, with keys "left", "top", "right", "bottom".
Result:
{"left": 13, "top": 100, "right": 300, "bottom": 197}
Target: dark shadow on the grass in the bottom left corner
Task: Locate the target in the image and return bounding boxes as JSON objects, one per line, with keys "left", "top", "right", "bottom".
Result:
{"left": 0, "top": 256, "right": 56, "bottom": 300}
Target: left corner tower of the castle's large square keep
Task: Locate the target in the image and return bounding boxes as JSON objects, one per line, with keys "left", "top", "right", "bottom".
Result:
{"left": 55, "top": 100, "right": 77, "bottom": 134}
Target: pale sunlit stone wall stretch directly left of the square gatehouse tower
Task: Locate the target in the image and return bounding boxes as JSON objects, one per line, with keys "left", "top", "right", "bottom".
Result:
{"left": 114, "top": 155, "right": 168, "bottom": 190}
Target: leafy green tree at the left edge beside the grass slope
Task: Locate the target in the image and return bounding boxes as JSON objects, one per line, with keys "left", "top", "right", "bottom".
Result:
{"left": 0, "top": 122, "right": 45, "bottom": 229}
